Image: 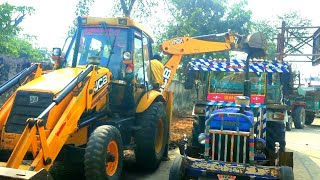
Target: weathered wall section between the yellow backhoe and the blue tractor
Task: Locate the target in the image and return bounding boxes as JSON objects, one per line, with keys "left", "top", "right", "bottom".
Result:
{"left": 169, "top": 80, "right": 196, "bottom": 115}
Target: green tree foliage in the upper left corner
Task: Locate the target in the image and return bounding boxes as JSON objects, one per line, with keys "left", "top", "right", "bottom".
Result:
{"left": 0, "top": 3, "right": 43, "bottom": 60}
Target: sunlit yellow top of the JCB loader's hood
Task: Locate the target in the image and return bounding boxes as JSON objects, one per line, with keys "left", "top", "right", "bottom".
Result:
{"left": 18, "top": 67, "right": 85, "bottom": 94}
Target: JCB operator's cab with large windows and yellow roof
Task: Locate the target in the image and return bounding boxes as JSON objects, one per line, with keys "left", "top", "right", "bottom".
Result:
{"left": 59, "top": 17, "right": 158, "bottom": 111}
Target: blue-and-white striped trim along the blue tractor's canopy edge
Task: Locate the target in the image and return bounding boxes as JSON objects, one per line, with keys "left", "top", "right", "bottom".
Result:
{"left": 189, "top": 59, "right": 289, "bottom": 73}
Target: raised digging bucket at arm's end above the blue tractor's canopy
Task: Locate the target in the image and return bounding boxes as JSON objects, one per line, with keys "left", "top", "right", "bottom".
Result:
{"left": 238, "top": 32, "right": 267, "bottom": 58}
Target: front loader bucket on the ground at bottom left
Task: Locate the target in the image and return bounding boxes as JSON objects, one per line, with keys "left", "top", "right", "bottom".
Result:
{"left": 0, "top": 167, "right": 53, "bottom": 180}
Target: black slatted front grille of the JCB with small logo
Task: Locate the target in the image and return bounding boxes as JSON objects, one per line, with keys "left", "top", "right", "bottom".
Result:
{"left": 5, "top": 91, "right": 53, "bottom": 133}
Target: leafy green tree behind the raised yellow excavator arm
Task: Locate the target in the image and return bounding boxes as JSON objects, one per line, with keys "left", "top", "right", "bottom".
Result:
{"left": 160, "top": 0, "right": 252, "bottom": 79}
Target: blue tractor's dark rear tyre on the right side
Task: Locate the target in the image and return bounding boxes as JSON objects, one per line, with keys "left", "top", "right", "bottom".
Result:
{"left": 266, "top": 121, "right": 286, "bottom": 152}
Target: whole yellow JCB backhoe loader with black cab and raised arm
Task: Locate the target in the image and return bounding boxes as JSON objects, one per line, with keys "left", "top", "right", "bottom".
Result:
{"left": 0, "top": 17, "right": 264, "bottom": 179}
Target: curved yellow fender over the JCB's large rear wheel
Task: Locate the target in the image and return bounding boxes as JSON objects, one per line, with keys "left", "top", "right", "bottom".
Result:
{"left": 136, "top": 90, "right": 165, "bottom": 113}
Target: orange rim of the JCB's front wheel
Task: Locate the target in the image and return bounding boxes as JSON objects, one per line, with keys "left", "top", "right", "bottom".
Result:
{"left": 106, "top": 141, "right": 119, "bottom": 176}
